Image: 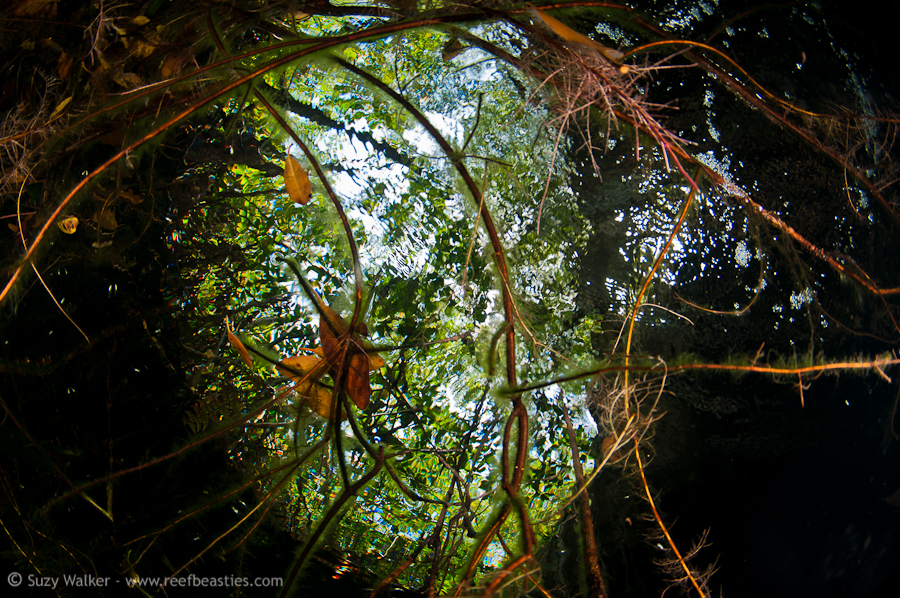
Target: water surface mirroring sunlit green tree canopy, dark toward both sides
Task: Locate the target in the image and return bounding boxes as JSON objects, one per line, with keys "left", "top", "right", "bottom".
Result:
{"left": 0, "top": 5, "right": 900, "bottom": 596}
